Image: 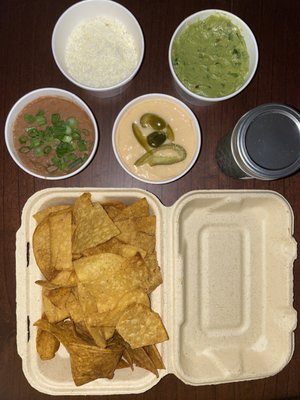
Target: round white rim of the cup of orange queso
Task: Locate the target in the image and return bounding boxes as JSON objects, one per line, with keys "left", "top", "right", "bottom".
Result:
{"left": 112, "top": 92, "right": 202, "bottom": 185}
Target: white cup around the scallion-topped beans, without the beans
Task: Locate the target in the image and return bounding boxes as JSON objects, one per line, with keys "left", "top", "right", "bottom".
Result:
{"left": 5, "top": 88, "right": 99, "bottom": 180}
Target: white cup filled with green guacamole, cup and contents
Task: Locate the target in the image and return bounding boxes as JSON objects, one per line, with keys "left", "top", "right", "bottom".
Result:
{"left": 168, "top": 10, "right": 258, "bottom": 104}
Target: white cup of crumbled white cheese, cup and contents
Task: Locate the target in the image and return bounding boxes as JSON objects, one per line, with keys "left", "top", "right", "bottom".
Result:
{"left": 52, "top": 0, "right": 144, "bottom": 97}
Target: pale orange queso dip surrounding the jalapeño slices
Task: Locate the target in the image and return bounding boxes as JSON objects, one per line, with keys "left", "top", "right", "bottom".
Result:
{"left": 114, "top": 96, "right": 200, "bottom": 182}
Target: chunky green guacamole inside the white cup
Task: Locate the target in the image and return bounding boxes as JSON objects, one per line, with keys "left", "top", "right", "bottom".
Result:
{"left": 172, "top": 14, "right": 249, "bottom": 97}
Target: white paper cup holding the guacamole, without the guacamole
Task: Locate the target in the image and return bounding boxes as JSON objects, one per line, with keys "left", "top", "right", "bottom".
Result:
{"left": 168, "top": 9, "right": 259, "bottom": 105}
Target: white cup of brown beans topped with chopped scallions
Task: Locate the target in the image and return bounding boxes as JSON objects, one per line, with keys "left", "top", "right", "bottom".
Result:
{"left": 5, "top": 88, "right": 98, "bottom": 180}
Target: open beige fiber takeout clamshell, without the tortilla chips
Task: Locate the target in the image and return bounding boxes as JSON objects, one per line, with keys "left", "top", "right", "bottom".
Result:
{"left": 16, "top": 188, "right": 297, "bottom": 395}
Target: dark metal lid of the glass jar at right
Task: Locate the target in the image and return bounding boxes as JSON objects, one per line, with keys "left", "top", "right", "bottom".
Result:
{"left": 231, "top": 103, "right": 300, "bottom": 180}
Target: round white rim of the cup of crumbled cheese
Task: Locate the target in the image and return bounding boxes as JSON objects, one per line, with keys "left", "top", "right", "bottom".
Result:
{"left": 51, "top": 0, "right": 145, "bottom": 93}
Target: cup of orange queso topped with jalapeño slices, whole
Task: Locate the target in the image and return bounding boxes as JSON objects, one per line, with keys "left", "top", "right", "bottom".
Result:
{"left": 112, "top": 93, "right": 201, "bottom": 184}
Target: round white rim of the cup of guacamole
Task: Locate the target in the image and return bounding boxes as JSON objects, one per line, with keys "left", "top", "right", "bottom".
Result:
{"left": 168, "top": 8, "right": 259, "bottom": 103}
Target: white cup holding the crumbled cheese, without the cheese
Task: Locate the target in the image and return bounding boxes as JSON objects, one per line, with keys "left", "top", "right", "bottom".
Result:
{"left": 52, "top": 0, "right": 144, "bottom": 98}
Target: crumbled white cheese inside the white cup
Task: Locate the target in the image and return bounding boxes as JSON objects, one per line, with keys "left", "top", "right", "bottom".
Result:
{"left": 65, "top": 16, "right": 138, "bottom": 88}
